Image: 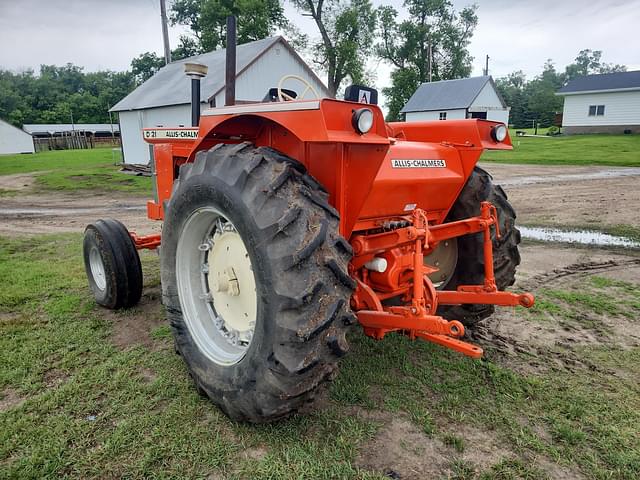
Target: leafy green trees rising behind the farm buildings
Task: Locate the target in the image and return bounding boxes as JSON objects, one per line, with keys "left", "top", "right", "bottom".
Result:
{"left": 0, "top": 0, "right": 624, "bottom": 127}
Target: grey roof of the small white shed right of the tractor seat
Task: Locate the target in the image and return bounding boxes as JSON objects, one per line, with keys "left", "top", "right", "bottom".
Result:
{"left": 400, "top": 76, "right": 506, "bottom": 113}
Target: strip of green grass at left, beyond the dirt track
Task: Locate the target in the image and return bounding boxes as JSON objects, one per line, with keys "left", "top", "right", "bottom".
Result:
{"left": 0, "top": 148, "right": 151, "bottom": 195}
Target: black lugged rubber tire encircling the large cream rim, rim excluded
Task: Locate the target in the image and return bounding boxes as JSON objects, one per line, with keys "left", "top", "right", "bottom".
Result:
{"left": 161, "top": 142, "right": 355, "bottom": 423}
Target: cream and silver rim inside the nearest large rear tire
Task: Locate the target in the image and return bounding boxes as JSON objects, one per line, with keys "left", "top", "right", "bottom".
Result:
{"left": 176, "top": 207, "right": 258, "bottom": 365}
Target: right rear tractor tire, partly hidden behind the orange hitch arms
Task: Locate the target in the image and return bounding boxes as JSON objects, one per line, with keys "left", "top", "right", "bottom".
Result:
{"left": 438, "top": 167, "right": 520, "bottom": 327}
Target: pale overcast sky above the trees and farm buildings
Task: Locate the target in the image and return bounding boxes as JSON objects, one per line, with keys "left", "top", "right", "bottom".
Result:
{"left": 0, "top": 0, "right": 640, "bottom": 88}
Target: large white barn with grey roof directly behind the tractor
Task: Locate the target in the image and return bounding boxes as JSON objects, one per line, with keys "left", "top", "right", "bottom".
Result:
{"left": 111, "top": 37, "right": 329, "bottom": 164}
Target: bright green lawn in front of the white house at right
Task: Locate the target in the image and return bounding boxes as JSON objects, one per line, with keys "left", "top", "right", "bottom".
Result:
{"left": 482, "top": 129, "right": 640, "bottom": 167}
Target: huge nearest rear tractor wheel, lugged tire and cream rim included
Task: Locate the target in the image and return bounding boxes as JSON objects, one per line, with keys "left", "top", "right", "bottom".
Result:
{"left": 161, "top": 143, "right": 354, "bottom": 422}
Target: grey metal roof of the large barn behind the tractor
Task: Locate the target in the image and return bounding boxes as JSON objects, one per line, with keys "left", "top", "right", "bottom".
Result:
{"left": 111, "top": 36, "right": 324, "bottom": 112}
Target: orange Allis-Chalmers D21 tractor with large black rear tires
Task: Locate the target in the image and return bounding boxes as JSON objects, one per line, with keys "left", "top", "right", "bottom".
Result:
{"left": 84, "top": 43, "right": 534, "bottom": 422}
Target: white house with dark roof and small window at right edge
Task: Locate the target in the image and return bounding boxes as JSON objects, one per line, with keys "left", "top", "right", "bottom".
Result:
{"left": 557, "top": 70, "right": 640, "bottom": 134}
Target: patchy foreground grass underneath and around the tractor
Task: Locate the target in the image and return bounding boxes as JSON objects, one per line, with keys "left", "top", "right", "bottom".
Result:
{"left": 0, "top": 235, "right": 640, "bottom": 480}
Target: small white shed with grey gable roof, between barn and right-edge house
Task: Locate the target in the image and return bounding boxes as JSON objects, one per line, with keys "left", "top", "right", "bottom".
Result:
{"left": 400, "top": 76, "right": 509, "bottom": 124}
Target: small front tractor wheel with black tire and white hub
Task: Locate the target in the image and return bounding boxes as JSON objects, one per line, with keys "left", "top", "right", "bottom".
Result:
{"left": 82, "top": 218, "right": 142, "bottom": 310}
